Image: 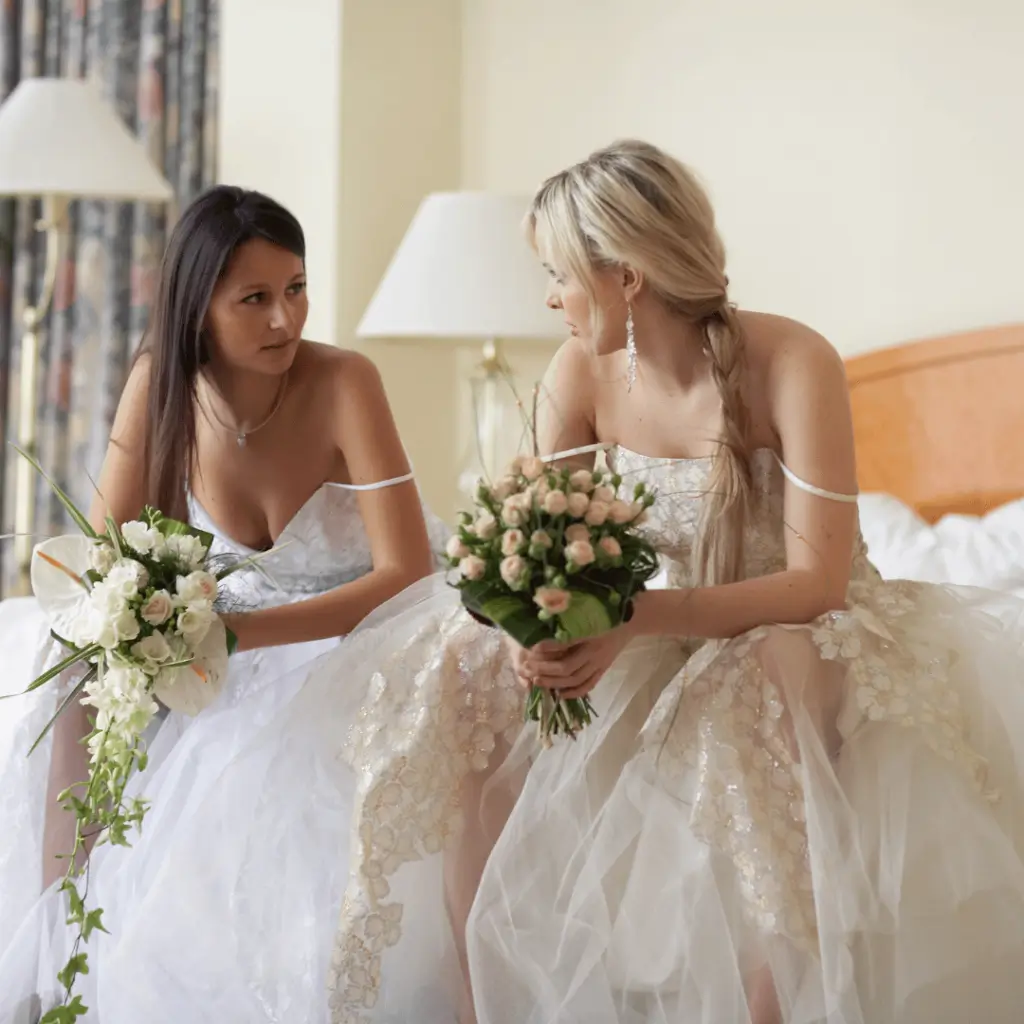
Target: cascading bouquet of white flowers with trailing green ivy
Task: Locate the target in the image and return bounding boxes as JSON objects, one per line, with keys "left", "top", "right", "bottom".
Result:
{"left": 9, "top": 453, "right": 241, "bottom": 1024}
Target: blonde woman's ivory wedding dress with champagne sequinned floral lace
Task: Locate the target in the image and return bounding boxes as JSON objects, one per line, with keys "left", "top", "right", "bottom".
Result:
{"left": 296, "top": 449, "right": 1024, "bottom": 1024}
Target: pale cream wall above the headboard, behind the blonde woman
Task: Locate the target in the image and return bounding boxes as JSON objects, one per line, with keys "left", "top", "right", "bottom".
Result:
{"left": 463, "top": 0, "right": 1024, "bottom": 352}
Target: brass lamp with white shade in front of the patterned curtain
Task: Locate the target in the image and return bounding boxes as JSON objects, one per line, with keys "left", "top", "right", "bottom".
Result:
{"left": 0, "top": 78, "right": 174, "bottom": 592}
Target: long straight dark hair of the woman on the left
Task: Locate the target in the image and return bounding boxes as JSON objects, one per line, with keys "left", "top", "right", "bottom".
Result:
{"left": 138, "top": 185, "right": 306, "bottom": 519}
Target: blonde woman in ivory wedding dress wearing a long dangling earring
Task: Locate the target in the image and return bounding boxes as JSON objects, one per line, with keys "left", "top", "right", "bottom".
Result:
{"left": 68, "top": 142, "right": 1024, "bottom": 1024}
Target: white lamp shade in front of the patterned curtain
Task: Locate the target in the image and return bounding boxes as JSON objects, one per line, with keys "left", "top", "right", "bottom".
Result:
{"left": 0, "top": 78, "right": 174, "bottom": 202}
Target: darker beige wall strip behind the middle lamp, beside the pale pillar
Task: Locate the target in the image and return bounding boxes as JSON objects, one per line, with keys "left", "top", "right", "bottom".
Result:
{"left": 336, "top": 0, "right": 462, "bottom": 518}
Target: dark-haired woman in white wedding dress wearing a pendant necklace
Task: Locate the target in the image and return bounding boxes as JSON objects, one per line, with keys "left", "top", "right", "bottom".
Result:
{"left": 0, "top": 186, "right": 448, "bottom": 1024}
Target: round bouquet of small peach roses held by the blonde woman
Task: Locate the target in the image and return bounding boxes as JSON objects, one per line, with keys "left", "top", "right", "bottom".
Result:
{"left": 447, "top": 456, "right": 657, "bottom": 742}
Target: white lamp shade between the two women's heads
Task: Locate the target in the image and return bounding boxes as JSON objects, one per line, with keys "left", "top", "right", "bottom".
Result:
{"left": 356, "top": 193, "right": 565, "bottom": 339}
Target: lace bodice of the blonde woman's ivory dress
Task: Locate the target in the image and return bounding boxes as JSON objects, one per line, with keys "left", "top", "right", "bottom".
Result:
{"left": 606, "top": 446, "right": 878, "bottom": 587}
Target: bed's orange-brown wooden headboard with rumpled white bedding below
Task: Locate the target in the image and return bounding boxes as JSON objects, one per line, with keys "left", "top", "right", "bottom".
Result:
{"left": 846, "top": 325, "right": 1024, "bottom": 594}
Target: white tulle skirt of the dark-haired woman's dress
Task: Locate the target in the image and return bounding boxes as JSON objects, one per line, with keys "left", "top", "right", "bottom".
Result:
{"left": 0, "top": 641, "right": 351, "bottom": 1024}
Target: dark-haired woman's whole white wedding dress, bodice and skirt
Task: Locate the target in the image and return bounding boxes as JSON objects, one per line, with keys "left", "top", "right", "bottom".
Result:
{"left": 0, "top": 481, "right": 446, "bottom": 1024}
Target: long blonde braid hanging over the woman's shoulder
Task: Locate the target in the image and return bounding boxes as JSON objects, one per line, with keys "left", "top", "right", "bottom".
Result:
{"left": 692, "top": 302, "right": 753, "bottom": 586}
